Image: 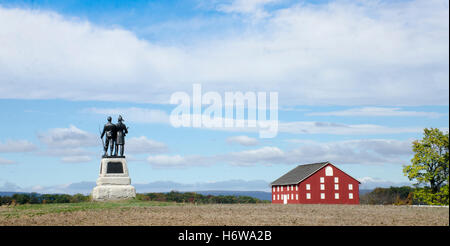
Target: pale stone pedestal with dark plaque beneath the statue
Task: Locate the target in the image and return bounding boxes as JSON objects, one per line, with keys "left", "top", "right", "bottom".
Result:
{"left": 92, "top": 158, "right": 136, "bottom": 201}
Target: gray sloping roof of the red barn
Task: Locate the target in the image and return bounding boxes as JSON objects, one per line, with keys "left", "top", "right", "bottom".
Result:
{"left": 271, "top": 161, "right": 329, "bottom": 185}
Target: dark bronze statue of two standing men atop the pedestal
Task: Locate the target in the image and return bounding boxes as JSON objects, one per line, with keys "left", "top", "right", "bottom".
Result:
{"left": 100, "top": 115, "right": 128, "bottom": 157}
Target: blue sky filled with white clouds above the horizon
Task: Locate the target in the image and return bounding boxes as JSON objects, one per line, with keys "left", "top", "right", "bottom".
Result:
{"left": 0, "top": 0, "right": 449, "bottom": 193}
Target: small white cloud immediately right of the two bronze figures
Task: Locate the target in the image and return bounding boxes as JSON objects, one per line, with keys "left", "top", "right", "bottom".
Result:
{"left": 126, "top": 136, "right": 168, "bottom": 154}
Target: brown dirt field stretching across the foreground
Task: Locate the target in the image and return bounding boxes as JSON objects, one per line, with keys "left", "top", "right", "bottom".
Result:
{"left": 0, "top": 204, "right": 449, "bottom": 226}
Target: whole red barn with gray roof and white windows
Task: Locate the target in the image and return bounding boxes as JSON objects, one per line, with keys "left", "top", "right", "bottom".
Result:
{"left": 271, "top": 162, "right": 360, "bottom": 204}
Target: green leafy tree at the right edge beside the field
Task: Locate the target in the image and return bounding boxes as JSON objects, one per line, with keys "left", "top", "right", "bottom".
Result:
{"left": 403, "top": 128, "right": 449, "bottom": 205}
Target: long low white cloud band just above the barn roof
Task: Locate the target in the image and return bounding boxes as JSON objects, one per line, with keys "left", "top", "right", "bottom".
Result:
{"left": 147, "top": 139, "right": 412, "bottom": 167}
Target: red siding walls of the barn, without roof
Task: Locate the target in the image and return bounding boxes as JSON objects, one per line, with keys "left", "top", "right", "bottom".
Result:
{"left": 272, "top": 164, "right": 359, "bottom": 204}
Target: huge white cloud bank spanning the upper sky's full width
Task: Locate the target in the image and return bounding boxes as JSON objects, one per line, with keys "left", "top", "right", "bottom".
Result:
{"left": 0, "top": 0, "right": 449, "bottom": 105}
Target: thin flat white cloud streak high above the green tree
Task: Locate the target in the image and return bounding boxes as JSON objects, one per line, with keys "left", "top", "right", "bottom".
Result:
{"left": 306, "top": 107, "right": 445, "bottom": 118}
